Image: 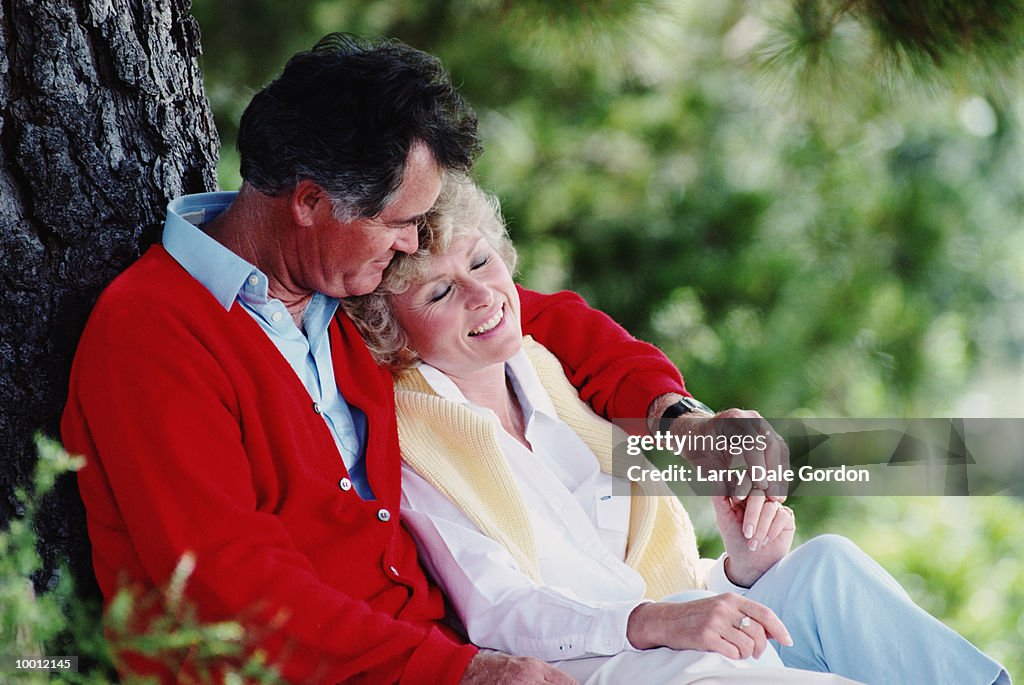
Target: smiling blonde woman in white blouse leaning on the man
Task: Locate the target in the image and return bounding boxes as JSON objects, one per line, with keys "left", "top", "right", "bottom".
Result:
{"left": 346, "top": 178, "right": 1010, "bottom": 685}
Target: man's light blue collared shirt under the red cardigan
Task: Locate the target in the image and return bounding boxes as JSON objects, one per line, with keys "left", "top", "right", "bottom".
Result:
{"left": 163, "top": 192, "right": 374, "bottom": 500}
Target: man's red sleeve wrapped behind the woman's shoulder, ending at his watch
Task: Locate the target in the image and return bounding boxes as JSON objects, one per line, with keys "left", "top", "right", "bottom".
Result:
{"left": 519, "top": 287, "right": 689, "bottom": 419}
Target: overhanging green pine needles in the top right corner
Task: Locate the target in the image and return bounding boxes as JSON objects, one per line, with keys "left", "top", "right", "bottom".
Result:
{"left": 748, "top": 0, "right": 1024, "bottom": 106}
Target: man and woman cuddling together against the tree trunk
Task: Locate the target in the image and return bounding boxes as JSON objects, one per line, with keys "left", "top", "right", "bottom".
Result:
{"left": 62, "top": 31, "right": 1010, "bottom": 685}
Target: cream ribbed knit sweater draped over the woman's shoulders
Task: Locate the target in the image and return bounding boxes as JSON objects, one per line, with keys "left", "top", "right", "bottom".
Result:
{"left": 395, "top": 336, "right": 706, "bottom": 599}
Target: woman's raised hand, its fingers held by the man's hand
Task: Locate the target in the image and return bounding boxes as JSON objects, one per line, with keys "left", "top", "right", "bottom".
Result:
{"left": 712, "top": 490, "right": 797, "bottom": 588}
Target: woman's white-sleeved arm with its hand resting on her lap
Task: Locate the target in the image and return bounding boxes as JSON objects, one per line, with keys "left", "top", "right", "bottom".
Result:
{"left": 401, "top": 467, "right": 792, "bottom": 661}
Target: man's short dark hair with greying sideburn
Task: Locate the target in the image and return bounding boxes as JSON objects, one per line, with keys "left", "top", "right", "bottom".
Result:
{"left": 238, "top": 34, "right": 480, "bottom": 218}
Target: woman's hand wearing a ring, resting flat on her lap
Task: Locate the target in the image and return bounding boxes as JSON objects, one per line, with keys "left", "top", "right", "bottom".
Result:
{"left": 626, "top": 593, "right": 793, "bottom": 658}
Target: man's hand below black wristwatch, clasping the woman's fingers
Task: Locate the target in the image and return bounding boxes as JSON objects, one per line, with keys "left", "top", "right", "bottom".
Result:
{"left": 647, "top": 393, "right": 790, "bottom": 502}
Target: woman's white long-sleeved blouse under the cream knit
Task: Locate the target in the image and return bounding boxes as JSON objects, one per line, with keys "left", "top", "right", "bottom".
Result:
{"left": 401, "top": 350, "right": 737, "bottom": 661}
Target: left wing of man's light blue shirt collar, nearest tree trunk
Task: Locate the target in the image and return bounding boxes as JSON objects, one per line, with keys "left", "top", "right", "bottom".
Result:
{"left": 163, "top": 192, "right": 267, "bottom": 309}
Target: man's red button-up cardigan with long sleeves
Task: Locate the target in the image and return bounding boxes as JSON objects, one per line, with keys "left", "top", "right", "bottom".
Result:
{"left": 61, "top": 246, "right": 683, "bottom": 684}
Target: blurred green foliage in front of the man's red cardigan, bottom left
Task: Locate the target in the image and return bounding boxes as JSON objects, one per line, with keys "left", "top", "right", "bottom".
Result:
{"left": 0, "top": 437, "right": 281, "bottom": 685}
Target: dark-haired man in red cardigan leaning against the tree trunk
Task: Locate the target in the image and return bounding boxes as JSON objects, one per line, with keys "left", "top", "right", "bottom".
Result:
{"left": 62, "top": 31, "right": 733, "bottom": 683}
